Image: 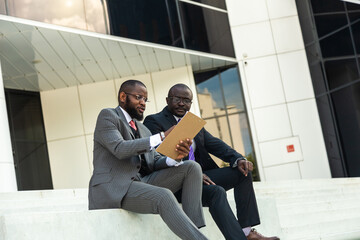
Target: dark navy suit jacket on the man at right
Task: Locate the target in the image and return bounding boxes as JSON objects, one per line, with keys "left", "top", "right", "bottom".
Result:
{"left": 144, "top": 107, "right": 242, "bottom": 171}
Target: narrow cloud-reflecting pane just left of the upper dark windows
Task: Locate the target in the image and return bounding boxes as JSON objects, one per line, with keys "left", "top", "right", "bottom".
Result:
{"left": 84, "top": 0, "right": 106, "bottom": 33}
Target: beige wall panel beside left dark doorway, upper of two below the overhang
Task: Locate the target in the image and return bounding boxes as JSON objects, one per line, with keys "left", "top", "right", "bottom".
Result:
{"left": 41, "top": 87, "right": 84, "bottom": 141}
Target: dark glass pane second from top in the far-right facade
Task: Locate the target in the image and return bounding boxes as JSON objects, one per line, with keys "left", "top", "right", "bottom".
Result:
{"left": 315, "top": 13, "right": 348, "bottom": 37}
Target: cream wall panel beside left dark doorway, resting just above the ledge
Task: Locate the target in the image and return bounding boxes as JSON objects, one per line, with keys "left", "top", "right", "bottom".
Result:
{"left": 48, "top": 136, "right": 90, "bottom": 189}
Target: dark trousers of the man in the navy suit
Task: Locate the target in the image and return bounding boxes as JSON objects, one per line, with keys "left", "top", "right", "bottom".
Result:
{"left": 202, "top": 167, "right": 260, "bottom": 240}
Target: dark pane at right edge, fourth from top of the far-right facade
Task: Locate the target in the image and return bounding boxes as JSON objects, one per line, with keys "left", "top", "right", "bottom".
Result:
{"left": 325, "top": 58, "right": 360, "bottom": 89}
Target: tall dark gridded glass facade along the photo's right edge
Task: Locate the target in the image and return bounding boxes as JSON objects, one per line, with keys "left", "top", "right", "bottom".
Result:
{"left": 296, "top": 0, "right": 360, "bottom": 177}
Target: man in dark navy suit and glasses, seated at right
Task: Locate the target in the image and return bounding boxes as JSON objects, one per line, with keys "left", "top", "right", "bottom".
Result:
{"left": 144, "top": 84, "right": 279, "bottom": 240}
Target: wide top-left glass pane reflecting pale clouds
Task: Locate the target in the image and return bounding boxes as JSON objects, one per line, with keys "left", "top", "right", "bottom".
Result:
{"left": 8, "top": 0, "right": 87, "bottom": 30}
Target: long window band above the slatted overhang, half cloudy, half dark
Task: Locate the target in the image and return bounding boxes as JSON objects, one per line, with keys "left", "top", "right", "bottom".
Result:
{"left": 0, "top": 0, "right": 235, "bottom": 57}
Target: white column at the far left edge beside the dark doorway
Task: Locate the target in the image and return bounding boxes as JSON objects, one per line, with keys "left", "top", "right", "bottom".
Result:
{"left": 0, "top": 59, "right": 17, "bottom": 192}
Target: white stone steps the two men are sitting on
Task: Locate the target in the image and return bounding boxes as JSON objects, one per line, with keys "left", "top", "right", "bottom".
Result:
{"left": 0, "top": 178, "right": 360, "bottom": 240}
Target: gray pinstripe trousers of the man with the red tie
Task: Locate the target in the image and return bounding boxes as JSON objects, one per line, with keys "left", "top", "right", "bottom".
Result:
{"left": 122, "top": 161, "right": 207, "bottom": 240}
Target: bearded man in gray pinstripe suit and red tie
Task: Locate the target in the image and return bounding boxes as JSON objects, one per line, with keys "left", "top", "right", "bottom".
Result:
{"left": 89, "top": 80, "right": 207, "bottom": 240}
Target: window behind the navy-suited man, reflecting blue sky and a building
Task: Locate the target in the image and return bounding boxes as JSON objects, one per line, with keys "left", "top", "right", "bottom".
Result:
{"left": 194, "top": 66, "right": 259, "bottom": 180}
